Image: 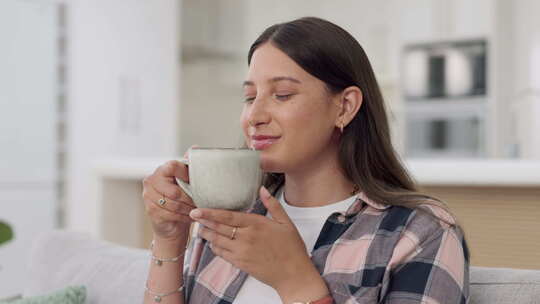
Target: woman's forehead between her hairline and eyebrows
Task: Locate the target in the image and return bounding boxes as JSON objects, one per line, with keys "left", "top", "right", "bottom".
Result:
{"left": 246, "top": 43, "right": 316, "bottom": 84}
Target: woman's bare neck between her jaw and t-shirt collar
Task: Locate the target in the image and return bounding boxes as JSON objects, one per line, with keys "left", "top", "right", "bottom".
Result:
{"left": 284, "top": 149, "right": 354, "bottom": 207}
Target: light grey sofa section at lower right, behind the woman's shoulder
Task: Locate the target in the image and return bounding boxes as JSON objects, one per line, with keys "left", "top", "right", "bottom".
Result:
{"left": 469, "top": 267, "right": 540, "bottom": 304}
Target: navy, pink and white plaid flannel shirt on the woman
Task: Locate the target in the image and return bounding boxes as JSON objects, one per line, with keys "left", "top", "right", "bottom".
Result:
{"left": 184, "top": 184, "right": 469, "bottom": 304}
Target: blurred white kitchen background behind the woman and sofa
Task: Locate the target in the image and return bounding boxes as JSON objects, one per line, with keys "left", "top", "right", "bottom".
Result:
{"left": 0, "top": 0, "right": 540, "bottom": 297}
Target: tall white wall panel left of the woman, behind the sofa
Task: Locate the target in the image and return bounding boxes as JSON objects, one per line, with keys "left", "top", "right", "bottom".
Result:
{"left": 66, "top": 0, "right": 180, "bottom": 235}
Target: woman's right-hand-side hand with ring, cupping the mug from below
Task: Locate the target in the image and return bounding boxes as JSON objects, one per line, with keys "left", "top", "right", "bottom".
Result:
{"left": 190, "top": 187, "right": 328, "bottom": 303}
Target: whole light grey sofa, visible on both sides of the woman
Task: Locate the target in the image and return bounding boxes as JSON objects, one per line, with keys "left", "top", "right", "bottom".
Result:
{"left": 24, "top": 231, "right": 540, "bottom": 304}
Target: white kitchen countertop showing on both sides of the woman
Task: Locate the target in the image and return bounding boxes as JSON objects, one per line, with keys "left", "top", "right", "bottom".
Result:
{"left": 93, "top": 158, "right": 540, "bottom": 187}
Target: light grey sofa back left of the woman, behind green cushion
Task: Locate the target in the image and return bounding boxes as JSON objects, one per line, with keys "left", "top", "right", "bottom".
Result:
{"left": 23, "top": 230, "right": 150, "bottom": 304}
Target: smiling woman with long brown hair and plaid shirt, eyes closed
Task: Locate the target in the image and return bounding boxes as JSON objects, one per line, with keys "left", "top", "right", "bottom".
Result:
{"left": 143, "top": 18, "right": 468, "bottom": 304}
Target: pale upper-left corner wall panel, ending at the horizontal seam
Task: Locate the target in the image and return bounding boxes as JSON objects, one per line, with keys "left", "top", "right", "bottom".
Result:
{"left": 0, "top": 0, "right": 57, "bottom": 185}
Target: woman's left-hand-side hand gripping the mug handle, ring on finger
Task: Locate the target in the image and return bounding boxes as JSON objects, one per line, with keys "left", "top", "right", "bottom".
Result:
{"left": 143, "top": 149, "right": 195, "bottom": 242}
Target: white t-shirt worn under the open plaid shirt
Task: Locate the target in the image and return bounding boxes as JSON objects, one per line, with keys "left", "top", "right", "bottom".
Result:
{"left": 233, "top": 187, "right": 357, "bottom": 304}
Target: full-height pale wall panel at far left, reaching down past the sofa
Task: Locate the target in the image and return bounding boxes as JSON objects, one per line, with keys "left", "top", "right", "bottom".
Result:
{"left": 0, "top": 0, "right": 58, "bottom": 298}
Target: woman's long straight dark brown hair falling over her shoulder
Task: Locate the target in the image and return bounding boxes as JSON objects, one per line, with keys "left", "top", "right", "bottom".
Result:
{"left": 248, "top": 17, "right": 454, "bottom": 221}
